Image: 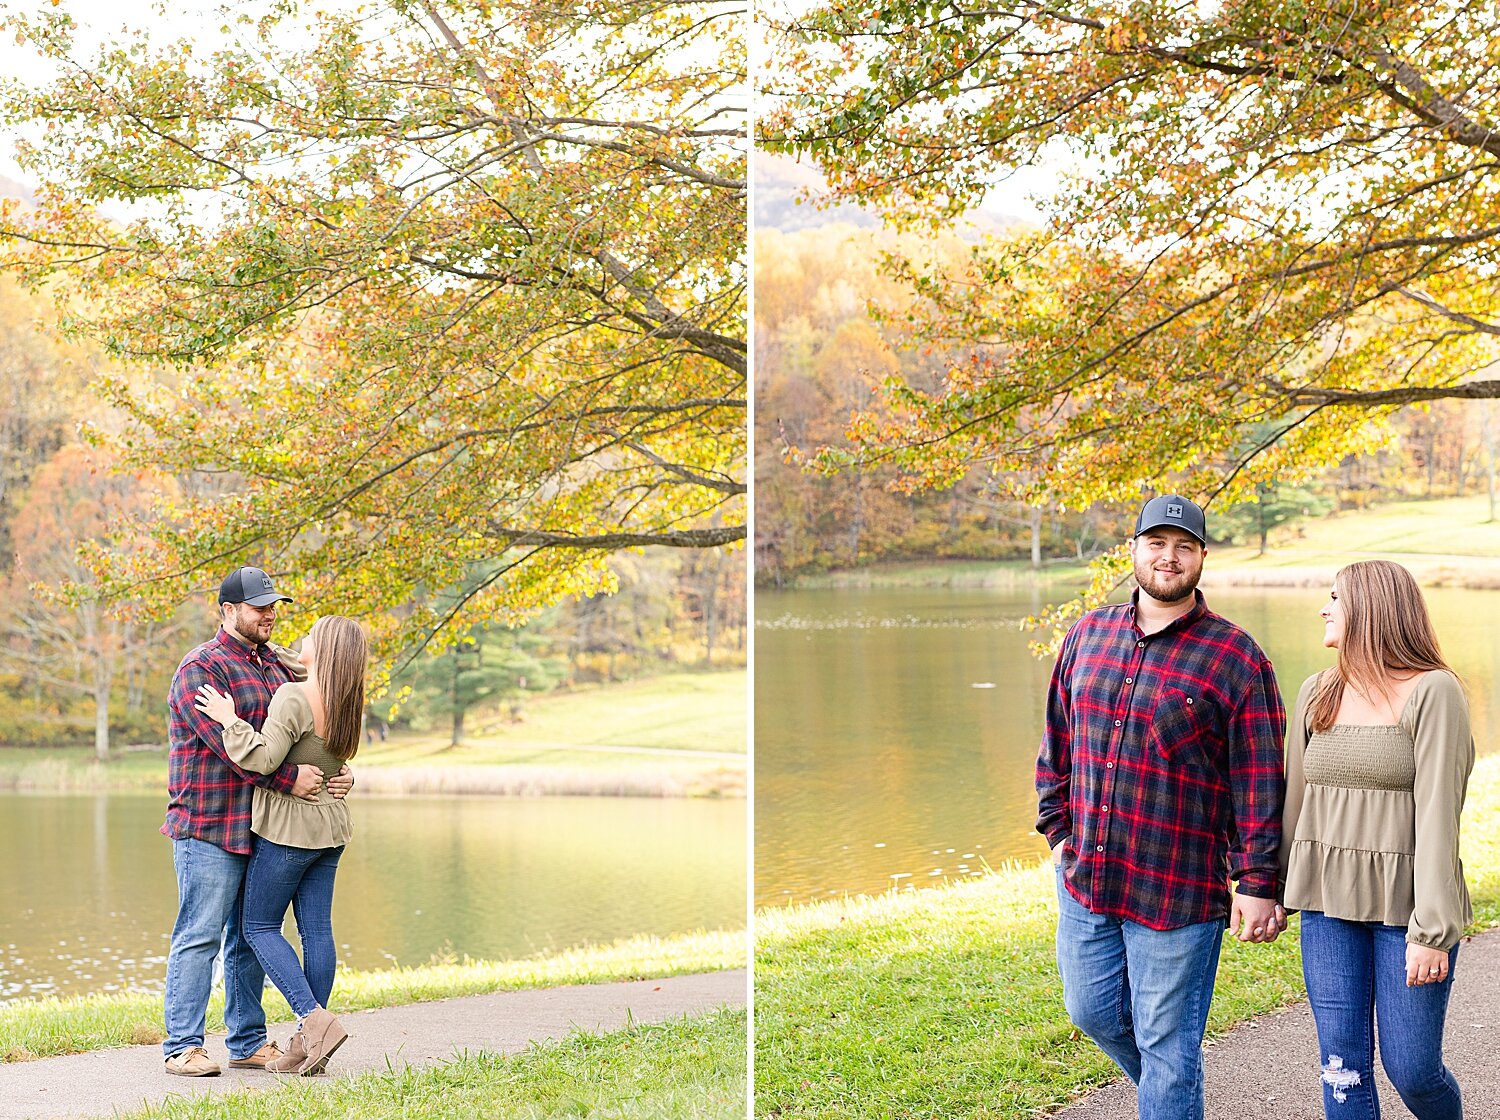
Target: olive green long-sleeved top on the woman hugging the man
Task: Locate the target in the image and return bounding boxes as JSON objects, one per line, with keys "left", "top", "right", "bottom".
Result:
{"left": 224, "top": 684, "right": 354, "bottom": 847}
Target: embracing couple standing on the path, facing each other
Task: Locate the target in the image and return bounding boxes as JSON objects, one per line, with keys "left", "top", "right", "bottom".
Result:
{"left": 162, "top": 567, "right": 369, "bottom": 1077}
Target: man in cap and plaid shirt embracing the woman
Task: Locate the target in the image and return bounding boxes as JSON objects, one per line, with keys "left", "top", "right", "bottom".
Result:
{"left": 162, "top": 568, "right": 354, "bottom": 1077}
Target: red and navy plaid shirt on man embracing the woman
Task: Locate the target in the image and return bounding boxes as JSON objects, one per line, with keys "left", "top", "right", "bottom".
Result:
{"left": 162, "top": 630, "right": 297, "bottom": 855}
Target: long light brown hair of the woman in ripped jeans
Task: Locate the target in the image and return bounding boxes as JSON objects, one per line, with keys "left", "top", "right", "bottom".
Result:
{"left": 1311, "top": 561, "right": 1457, "bottom": 732}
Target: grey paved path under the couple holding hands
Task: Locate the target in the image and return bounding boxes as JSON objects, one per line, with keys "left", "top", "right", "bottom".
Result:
{"left": 1053, "top": 931, "right": 1500, "bottom": 1120}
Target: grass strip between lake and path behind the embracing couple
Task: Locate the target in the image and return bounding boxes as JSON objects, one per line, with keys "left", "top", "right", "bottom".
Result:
{"left": 0, "top": 931, "right": 746, "bottom": 1062}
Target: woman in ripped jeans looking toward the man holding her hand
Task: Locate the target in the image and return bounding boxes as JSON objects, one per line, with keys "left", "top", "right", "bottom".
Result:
{"left": 1281, "top": 561, "right": 1475, "bottom": 1120}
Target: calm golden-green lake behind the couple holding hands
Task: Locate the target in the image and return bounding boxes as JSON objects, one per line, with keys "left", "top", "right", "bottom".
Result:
{"left": 755, "top": 588, "right": 1500, "bottom": 906}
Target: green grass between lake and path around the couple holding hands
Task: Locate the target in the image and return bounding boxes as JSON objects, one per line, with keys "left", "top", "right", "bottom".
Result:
{"left": 755, "top": 756, "right": 1500, "bottom": 1120}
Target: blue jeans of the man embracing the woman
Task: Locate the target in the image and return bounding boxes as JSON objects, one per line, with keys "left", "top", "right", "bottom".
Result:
{"left": 162, "top": 840, "right": 266, "bottom": 1059}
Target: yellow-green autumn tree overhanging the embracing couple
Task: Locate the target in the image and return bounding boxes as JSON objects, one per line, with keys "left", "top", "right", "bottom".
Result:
{"left": 0, "top": 0, "right": 746, "bottom": 652}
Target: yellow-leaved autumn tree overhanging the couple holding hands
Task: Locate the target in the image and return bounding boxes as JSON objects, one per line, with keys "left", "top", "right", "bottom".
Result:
{"left": 764, "top": 8, "right": 1500, "bottom": 588}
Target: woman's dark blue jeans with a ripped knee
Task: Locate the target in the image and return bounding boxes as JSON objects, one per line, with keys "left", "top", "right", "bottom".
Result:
{"left": 1302, "top": 910, "right": 1464, "bottom": 1120}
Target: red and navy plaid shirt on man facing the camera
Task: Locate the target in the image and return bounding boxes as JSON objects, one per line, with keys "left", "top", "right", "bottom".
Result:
{"left": 1037, "top": 591, "right": 1287, "bottom": 930}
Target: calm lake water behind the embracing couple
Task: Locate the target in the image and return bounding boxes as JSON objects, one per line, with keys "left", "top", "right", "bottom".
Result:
{"left": 0, "top": 793, "right": 746, "bottom": 999}
